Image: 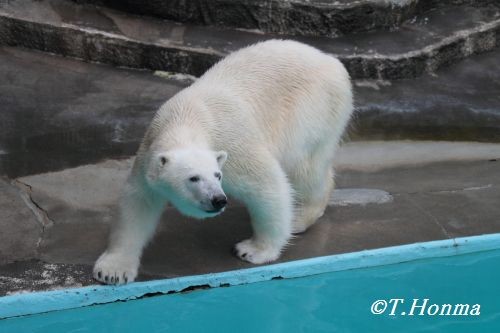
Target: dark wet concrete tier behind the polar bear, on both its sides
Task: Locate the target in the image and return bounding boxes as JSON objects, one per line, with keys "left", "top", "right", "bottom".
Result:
{"left": 0, "top": 47, "right": 500, "bottom": 177}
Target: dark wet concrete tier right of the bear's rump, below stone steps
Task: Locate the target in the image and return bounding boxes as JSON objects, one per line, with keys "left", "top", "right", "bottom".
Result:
{"left": 351, "top": 49, "right": 500, "bottom": 142}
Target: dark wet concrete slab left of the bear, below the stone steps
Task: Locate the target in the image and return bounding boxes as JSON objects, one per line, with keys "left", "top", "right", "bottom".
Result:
{"left": 0, "top": 47, "right": 186, "bottom": 177}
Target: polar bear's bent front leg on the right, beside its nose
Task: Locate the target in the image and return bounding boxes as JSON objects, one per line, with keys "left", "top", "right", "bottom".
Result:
{"left": 233, "top": 160, "right": 293, "bottom": 264}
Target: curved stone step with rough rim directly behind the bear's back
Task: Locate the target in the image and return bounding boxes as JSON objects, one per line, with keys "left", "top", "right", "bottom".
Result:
{"left": 0, "top": 0, "right": 500, "bottom": 79}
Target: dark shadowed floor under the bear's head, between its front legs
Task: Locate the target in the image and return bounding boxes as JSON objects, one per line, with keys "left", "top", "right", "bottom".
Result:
{"left": 139, "top": 202, "right": 253, "bottom": 280}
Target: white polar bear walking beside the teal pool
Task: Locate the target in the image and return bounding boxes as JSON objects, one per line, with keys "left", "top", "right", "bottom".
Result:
{"left": 94, "top": 40, "right": 353, "bottom": 284}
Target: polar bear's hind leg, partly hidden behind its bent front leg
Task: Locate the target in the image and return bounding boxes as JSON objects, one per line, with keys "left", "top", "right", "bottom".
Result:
{"left": 292, "top": 163, "right": 334, "bottom": 234}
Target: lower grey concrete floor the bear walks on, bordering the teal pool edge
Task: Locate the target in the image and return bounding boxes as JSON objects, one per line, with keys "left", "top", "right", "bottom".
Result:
{"left": 0, "top": 142, "right": 500, "bottom": 294}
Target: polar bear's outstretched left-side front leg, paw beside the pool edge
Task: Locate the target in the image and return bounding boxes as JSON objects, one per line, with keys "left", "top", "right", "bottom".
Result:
{"left": 94, "top": 186, "right": 165, "bottom": 284}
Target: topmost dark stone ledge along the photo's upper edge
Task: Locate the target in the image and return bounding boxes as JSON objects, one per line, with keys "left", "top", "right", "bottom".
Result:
{"left": 74, "top": 0, "right": 495, "bottom": 37}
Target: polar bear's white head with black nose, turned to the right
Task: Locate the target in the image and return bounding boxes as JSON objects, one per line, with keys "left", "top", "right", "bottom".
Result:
{"left": 146, "top": 149, "right": 227, "bottom": 219}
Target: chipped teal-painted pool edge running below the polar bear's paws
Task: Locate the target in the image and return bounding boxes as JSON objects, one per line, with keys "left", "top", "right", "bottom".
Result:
{"left": 0, "top": 233, "right": 500, "bottom": 319}
